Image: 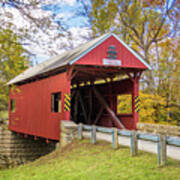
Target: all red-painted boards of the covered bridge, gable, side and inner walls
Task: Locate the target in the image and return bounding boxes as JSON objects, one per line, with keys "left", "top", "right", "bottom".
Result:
{"left": 9, "top": 33, "right": 147, "bottom": 140}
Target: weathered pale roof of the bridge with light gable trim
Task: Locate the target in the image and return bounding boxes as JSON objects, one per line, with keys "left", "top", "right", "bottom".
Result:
{"left": 7, "top": 33, "right": 151, "bottom": 85}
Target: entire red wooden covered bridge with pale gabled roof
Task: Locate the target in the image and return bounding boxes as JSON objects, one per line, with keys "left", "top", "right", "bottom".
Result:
{"left": 8, "top": 33, "right": 150, "bottom": 140}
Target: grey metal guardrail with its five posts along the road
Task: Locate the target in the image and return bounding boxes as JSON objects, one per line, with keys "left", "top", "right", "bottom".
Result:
{"left": 78, "top": 123, "right": 180, "bottom": 165}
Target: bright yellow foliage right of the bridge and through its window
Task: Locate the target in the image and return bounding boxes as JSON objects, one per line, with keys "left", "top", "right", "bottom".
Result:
{"left": 117, "top": 92, "right": 180, "bottom": 125}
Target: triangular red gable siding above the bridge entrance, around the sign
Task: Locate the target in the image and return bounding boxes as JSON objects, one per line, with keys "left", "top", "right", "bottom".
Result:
{"left": 75, "top": 36, "right": 147, "bottom": 69}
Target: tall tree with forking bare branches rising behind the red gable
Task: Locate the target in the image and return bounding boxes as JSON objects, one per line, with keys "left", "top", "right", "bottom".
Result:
{"left": 81, "top": 0, "right": 179, "bottom": 92}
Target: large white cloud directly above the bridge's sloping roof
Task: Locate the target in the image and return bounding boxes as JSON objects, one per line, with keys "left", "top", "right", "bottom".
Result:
{"left": 23, "top": 27, "right": 92, "bottom": 62}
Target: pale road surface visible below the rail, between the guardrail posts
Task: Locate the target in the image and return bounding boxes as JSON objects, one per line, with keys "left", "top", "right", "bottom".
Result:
{"left": 83, "top": 132, "right": 180, "bottom": 160}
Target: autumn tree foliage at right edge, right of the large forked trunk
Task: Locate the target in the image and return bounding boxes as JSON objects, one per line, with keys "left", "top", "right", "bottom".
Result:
{"left": 152, "top": 37, "right": 180, "bottom": 125}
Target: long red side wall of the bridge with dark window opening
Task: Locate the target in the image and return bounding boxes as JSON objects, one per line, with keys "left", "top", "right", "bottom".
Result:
{"left": 9, "top": 73, "right": 70, "bottom": 140}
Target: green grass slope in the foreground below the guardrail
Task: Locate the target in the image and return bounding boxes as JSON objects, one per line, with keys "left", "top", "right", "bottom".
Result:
{"left": 0, "top": 140, "right": 180, "bottom": 180}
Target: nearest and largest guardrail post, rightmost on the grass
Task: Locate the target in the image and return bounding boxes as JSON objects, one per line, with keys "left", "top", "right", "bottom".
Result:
{"left": 157, "top": 135, "right": 167, "bottom": 166}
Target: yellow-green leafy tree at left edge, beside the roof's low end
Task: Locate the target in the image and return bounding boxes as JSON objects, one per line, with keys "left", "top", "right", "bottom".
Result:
{"left": 0, "top": 30, "right": 29, "bottom": 111}
